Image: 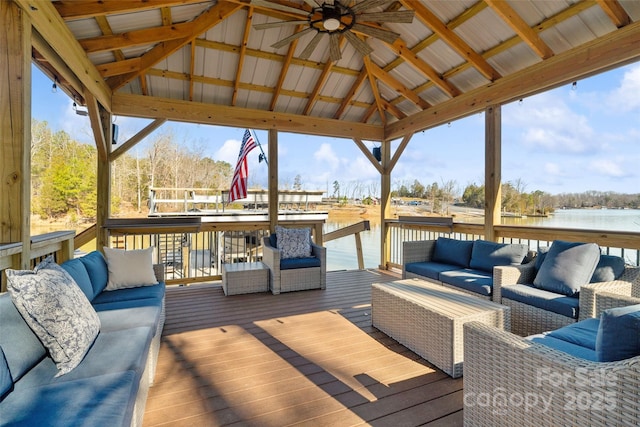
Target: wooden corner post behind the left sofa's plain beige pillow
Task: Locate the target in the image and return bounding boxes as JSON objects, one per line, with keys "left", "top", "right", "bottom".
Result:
{"left": 92, "top": 104, "right": 111, "bottom": 251}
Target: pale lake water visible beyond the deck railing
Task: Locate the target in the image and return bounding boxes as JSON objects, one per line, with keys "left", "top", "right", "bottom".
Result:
{"left": 325, "top": 209, "right": 640, "bottom": 271}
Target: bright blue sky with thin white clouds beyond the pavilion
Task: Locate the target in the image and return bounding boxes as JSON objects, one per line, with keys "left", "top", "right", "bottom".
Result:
{"left": 32, "top": 59, "right": 640, "bottom": 197}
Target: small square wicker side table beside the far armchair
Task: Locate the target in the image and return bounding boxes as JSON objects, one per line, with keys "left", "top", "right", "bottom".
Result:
{"left": 222, "top": 262, "right": 269, "bottom": 295}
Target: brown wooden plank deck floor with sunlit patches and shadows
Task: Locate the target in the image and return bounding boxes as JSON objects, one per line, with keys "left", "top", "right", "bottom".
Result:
{"left": 144, "top": 271, "right": 462, "bottom": 427}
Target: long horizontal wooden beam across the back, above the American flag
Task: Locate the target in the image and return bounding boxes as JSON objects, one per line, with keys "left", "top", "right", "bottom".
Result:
{"left": 113, "top": 93, "right": 384, "bottom": 141}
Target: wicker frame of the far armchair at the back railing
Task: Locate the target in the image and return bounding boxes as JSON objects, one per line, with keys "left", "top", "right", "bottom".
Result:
{"left": 262, "top": 236, "right": 327, "bottom": 294}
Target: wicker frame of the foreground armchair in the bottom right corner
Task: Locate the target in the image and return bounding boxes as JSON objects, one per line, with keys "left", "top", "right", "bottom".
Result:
{"left": 464, "top": 293, "right": 640, "bottom": 427}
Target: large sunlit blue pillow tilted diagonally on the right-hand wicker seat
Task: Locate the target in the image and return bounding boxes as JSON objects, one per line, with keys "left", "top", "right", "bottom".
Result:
{"left": 533, "top": 240, "right": 600, "bottom": 296}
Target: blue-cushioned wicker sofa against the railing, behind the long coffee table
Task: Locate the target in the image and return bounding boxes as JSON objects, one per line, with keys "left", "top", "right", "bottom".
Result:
{"left": 402, "top": 237, "right": 534, "bottom": 300}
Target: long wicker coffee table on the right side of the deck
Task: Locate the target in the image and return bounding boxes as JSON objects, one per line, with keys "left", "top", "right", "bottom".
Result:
{"left": 371, "top": 279, "right": 511, "bottom": 378}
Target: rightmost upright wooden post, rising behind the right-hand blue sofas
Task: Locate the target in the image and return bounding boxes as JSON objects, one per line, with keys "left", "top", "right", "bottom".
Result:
{"left": 484, "top": 105, "right": 502, "bottom": 241}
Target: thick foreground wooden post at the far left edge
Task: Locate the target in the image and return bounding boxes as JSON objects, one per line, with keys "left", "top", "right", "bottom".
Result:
{"left": 0, "top": 1, "right": 31, "bottom": 268}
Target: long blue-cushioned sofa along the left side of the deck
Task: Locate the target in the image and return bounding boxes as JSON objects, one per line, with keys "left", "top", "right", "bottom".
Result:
{"left": 0, "top": 251, "right": 165, "bottom": 427}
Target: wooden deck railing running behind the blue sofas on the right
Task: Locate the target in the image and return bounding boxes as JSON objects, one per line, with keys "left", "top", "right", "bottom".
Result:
{"left": 386, "top": 219, "right": 640, "bottom": 268}
